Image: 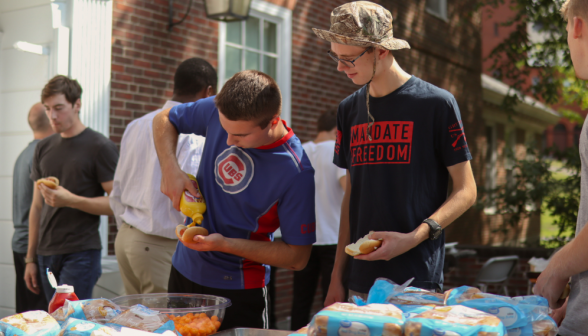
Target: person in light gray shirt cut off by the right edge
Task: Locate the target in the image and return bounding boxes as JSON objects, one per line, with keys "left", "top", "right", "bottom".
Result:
{"left": 534, "top": 0, "right": 588, "bottom": 336}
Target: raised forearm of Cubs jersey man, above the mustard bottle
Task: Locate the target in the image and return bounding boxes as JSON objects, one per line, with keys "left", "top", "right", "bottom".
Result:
{"left": 153, "top": 109, "right": 181, "bottom": 171}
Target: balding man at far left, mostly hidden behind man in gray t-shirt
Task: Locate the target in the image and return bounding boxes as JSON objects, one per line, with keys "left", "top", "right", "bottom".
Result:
{"left": 12, "top": 103, "right": 55, "bottom": 313}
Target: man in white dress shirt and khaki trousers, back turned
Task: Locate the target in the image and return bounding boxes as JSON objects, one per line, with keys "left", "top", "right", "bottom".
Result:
{"left": 110, "top": 58, "right": 217, "bottom": 295}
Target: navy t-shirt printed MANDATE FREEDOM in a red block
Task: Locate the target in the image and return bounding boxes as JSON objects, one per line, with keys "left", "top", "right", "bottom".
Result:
{"left": 334, "top": 76, "right": 472, "bottom": 293}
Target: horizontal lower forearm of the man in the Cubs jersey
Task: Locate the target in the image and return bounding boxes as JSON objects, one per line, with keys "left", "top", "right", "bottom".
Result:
{"left": 220, "top": 238, "right": 312, "bottom": 271}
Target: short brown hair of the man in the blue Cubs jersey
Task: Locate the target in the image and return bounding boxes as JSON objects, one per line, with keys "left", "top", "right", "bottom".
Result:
{"left": 215, "top": 70, "right": 282, "bottom": 129}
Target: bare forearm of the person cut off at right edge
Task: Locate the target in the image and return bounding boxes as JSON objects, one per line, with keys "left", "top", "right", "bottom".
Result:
{"left": 550, "top": 225, "right": 588, "bottom": 279}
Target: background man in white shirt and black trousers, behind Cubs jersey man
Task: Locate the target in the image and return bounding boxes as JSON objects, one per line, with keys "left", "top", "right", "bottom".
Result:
{"left": 291, "top": 110, "right": 346, "bottom": 330}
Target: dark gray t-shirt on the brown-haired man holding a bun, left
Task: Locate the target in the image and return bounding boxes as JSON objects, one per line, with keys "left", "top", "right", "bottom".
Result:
{"left": 31, "top": 128, "right": 118, "bottom": 256}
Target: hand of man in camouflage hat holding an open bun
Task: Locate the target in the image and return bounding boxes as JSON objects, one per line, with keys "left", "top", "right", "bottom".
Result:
{"left": 355, "top": 231, "right": 417, "bottom": 261}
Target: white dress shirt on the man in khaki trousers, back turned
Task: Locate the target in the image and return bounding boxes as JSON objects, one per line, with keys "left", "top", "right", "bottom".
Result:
{"left": 110, "top": 101, "right": 205, "bottom": 239}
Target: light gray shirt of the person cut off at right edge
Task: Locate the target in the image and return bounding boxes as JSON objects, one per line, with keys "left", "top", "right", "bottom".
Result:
{"left": 559, "top": 118, "right": 588, "bottom": 336}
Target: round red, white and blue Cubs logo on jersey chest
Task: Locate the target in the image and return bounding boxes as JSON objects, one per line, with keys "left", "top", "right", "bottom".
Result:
{"left": 214, "top": 146, "right": 253, "bottom": 194}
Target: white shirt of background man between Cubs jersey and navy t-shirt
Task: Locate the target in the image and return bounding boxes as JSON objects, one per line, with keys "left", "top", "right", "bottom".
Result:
{"left": 302, "top": 140, "right": 347, "bottom": 245}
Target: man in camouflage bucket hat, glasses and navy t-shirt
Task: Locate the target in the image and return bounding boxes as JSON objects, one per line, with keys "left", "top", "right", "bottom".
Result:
{"left": 313, "top": 1, "right": 476, "bottom": 305}
